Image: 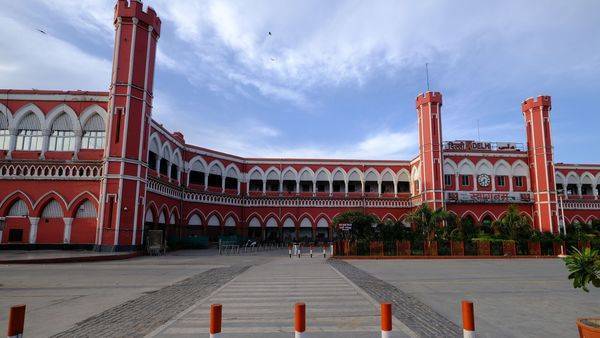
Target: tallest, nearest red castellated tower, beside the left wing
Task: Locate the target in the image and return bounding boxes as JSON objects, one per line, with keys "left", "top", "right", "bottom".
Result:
{"left": 96, "top": 0, "right": 161, "bottom": 250}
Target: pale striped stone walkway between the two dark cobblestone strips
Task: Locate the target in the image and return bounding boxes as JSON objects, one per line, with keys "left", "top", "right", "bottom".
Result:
{"left": 149, "top": 256, "right": 414, "bottom": 338}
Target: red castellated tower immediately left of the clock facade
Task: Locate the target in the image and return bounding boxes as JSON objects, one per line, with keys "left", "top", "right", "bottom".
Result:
{"left": 415, "top": 92, "right": 444, "bottom": 209}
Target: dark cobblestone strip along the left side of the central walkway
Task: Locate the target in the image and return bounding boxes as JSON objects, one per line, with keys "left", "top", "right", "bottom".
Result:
{"left": 53, "top": 266, "right": 249, "bottom": 337}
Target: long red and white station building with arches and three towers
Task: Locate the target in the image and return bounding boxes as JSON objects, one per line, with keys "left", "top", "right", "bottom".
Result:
{"left": 0, "top": 0, "right": 600, "bottom": 250}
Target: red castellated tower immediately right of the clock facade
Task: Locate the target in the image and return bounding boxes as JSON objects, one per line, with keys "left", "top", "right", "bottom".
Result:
{"left": 521, "top": 96, "right": 558, "bottom": 232}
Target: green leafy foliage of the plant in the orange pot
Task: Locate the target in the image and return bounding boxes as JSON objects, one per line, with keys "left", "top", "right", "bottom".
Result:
{"left": 564, "top": 248, "right": 600, "bottom": 292}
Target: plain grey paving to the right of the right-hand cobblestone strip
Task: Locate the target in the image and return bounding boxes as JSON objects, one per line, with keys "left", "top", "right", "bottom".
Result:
{"left": 350, "top": 259, "right": 600, "bottom": 337}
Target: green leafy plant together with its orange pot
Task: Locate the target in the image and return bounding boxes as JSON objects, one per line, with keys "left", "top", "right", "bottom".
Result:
{"left": 564, "top": 248, "right": 600, "bottom": 338}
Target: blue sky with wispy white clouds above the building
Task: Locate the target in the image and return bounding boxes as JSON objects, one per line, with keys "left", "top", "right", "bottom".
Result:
{"left": 0, "top": 0, "right": 600, "bottom": 163}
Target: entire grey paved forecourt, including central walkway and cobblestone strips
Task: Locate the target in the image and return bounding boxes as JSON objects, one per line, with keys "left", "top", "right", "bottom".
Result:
{"left": 0, "top": 250, "right": 600, "bottom": 338}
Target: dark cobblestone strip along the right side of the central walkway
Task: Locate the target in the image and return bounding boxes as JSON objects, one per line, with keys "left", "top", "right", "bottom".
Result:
{"left": 328, "top": 259, "right": 463, "bottom": 337}
